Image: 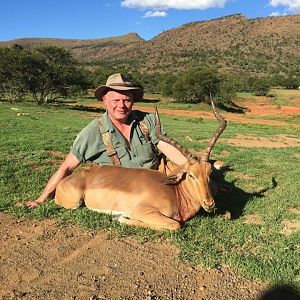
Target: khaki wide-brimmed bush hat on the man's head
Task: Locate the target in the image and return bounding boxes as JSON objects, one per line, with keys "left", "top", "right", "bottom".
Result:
{"left": 94, "top": 73, "right": 144, "bottom": 102}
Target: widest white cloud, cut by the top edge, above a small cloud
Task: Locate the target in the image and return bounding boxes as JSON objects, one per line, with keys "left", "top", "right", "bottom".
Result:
{"left": 121, "top": 0, "right": 231, "bottom": 10}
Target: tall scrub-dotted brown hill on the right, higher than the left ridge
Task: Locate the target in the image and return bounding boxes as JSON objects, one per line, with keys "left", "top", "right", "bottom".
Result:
{"left": 127, "top": 15, "right": 300, "bottom": 75}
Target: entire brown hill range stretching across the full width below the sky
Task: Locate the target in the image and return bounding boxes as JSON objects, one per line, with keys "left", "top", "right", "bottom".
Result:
{"left": 0, "top": 14, "right": 300, "bottom": 75}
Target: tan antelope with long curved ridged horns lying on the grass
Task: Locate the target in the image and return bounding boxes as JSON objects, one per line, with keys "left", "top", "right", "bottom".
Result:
{"left": 54, "top": 99, "right": 227, "bottom": 230}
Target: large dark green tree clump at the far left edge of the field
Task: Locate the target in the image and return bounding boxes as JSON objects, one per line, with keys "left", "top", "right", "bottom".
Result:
{"left": 0, "top": 45, "right": 89, "bottom": 104}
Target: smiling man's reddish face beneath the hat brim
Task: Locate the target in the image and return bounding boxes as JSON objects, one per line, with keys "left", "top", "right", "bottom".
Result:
{"left": 103, "top": 91, "right": 133, "bottom": 123}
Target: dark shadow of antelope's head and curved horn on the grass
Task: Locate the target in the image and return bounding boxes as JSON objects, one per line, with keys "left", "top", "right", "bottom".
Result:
{"left": 213, "top": 173, "right": 277, "bottom": 219}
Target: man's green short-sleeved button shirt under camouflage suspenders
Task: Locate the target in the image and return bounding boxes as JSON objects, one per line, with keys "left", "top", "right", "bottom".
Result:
{"left": 70, "top": 110, "right": 159, "bottom": 169}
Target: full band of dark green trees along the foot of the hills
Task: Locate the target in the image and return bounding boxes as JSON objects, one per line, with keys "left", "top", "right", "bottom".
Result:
{"left": 0, "top": 45, "right": 300, "bottom": 104}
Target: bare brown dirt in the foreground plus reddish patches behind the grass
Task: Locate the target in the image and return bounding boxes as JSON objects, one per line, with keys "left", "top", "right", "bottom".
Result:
{"left": 0, "top": 97, "right": 300, "bottom": 300}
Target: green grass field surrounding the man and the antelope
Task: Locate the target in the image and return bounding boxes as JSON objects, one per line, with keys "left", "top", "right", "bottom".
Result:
{"left": 0, "top": 103, "right": 300, "bottom": 284}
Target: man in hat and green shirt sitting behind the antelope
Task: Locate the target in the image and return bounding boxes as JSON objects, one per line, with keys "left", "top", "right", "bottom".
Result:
{"left": 25, "top": 74, "right": 186, "bottom": 208}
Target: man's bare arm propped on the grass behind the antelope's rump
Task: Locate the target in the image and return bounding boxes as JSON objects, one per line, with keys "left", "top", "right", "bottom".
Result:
{"left": 17, "top": 152, "right": 80, "bottom": 208}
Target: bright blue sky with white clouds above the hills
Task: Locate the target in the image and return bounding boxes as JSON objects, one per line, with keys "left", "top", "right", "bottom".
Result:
{"left": 0, "top": 0, "right": 300, "bottom": 41}
